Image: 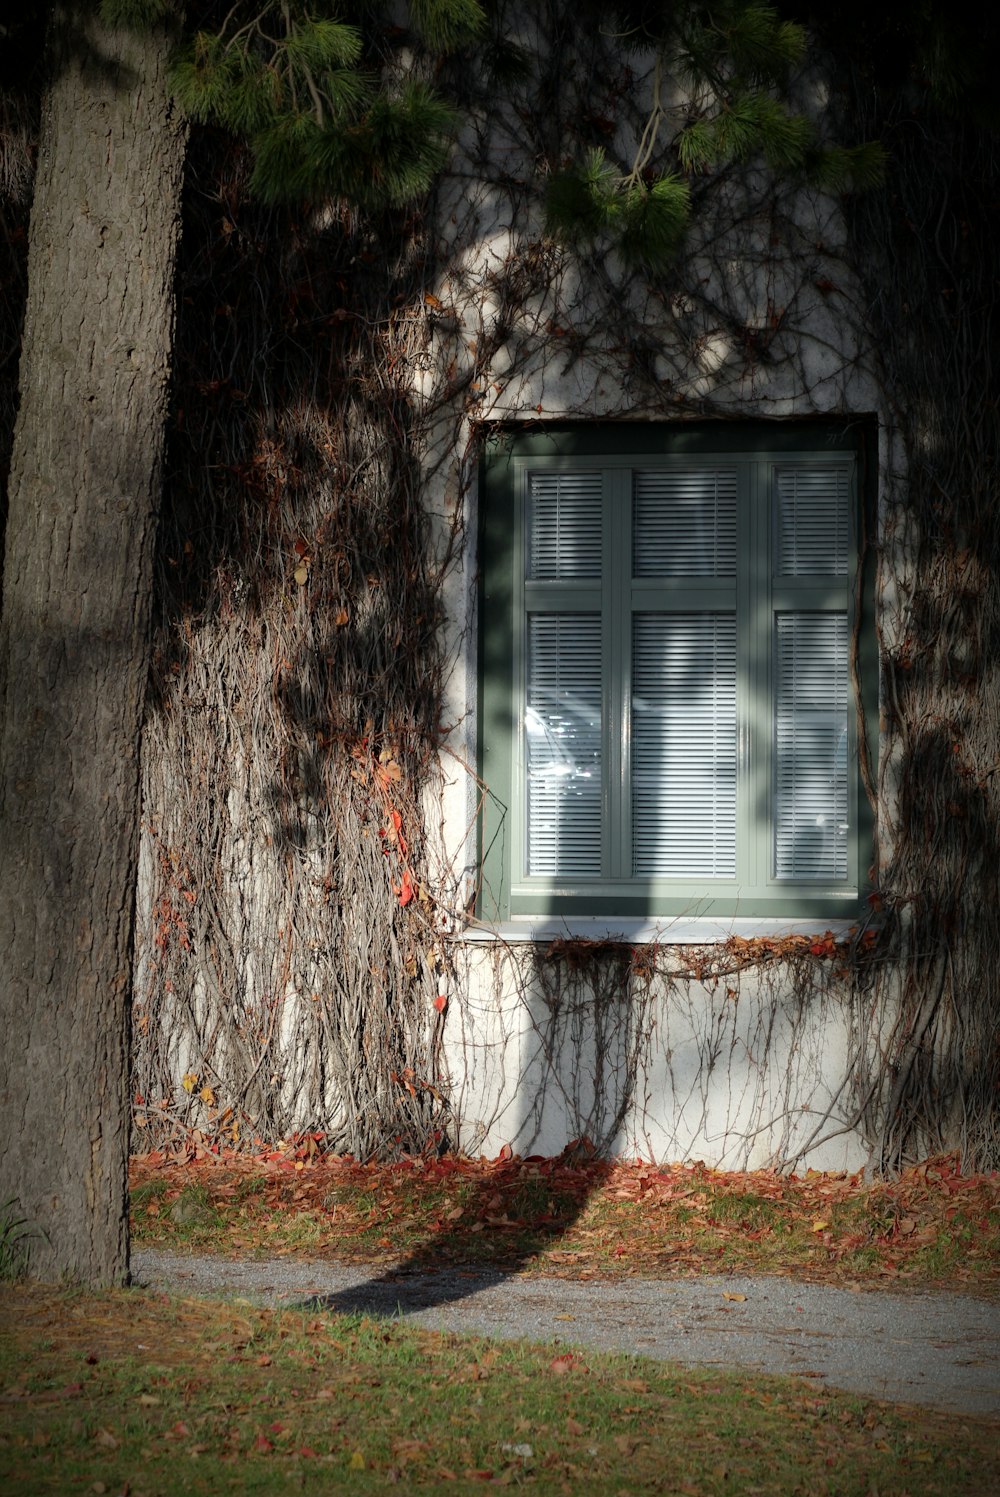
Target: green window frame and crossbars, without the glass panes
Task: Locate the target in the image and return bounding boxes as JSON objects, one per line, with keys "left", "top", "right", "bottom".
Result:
{"left": 476, "top": 419, "right": 877, "bottom": 924}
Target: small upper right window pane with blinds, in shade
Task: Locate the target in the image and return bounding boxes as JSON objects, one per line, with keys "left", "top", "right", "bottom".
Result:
{"left": 775, "top": 464, "right": 850, "bottom": 576}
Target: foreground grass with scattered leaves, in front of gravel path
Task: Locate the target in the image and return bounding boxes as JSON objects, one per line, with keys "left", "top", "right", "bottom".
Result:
{"left": 0, "top": 1286, "right": 1000, "bottom": 1497}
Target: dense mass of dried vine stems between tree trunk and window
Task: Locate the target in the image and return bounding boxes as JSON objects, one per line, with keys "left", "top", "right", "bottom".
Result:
{"left": 136, "top": 128, "right": 458, "bottom": 1157}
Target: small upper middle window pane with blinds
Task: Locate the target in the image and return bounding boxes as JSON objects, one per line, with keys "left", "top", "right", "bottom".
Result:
{"left": 632, "top": 469, "right": 737, "bottom": 578}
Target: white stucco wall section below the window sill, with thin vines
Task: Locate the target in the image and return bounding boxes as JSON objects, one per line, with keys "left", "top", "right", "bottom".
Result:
{"left": 446, "top": 948, "right": 867, "bottom": 1171}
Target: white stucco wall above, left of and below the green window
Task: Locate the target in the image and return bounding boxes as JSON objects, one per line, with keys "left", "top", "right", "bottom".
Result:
{"left": 413, "top": 43, "right": 894, "bottom": 1169}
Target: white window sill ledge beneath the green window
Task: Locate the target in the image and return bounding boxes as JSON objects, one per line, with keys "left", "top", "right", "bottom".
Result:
{"left": 454, "top": 916, "right": 858, "bottom": 946}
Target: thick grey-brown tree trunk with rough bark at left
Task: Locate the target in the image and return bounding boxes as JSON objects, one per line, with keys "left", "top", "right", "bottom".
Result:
{"left": 0, "top": 6, "right": 186, "bottom": 1284}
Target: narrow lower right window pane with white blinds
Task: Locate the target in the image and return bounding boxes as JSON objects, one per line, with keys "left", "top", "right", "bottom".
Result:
{"left": 774, "top": 612, "right": 849, "bottom": 879}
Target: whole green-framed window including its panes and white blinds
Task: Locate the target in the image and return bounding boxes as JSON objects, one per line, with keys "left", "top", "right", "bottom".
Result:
{"left": 476, "top": 421, "right": 876, "bottom": 924}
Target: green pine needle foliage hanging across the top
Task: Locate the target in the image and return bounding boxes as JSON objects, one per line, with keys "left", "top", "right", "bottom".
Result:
{"left": 99, "top": 0, "right": 885, "bottom": 271}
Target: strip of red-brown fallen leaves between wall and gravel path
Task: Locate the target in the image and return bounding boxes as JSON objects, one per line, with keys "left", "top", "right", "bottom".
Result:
{"left": 130, "top": 1135, "right": 1000, "bottom": 1293}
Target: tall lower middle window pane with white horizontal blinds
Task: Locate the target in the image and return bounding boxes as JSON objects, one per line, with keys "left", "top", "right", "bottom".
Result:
{"left": 632, "top": 614, "right": 737, "bottom": 879}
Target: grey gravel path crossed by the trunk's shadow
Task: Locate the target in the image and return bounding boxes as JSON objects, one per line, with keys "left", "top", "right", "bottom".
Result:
{"left": 132, "top": 1250, "right": 1000, "bottom": 1419}
